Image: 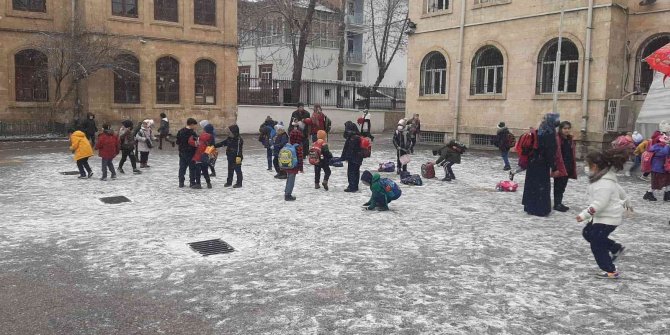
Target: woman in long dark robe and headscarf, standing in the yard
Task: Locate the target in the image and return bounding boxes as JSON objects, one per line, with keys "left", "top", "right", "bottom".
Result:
{"left": 522, "top": 113, "right": 560, "bottom": 216}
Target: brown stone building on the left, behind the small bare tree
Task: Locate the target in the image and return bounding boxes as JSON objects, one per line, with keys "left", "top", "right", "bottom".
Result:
{"left": 0, "top": 0, "right": 237, "bottom": 131}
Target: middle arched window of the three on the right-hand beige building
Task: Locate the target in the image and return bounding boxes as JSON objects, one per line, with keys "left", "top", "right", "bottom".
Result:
{"left": 470, "top": 45, "right": 504, "bottom": 95}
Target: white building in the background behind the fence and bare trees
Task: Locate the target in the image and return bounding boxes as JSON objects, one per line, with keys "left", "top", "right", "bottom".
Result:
{"left": 238, "top": 0, "right": 407, "bottom": 86}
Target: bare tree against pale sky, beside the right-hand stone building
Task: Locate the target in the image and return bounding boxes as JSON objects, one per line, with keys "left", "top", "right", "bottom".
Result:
{"left": 366, "top": 0, "right": 409, "bottom": 89}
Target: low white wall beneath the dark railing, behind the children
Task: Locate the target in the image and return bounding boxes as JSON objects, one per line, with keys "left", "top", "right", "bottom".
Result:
{"left": 237, "top": 105, "right": 385, "bottom": 134}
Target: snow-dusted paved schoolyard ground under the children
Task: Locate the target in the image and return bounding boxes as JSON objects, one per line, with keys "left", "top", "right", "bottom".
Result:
{"left": 0, "top": 140, "right": 670, "bottom": 334}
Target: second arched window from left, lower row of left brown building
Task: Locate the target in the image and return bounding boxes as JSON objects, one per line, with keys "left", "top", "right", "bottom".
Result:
{"left": 114, "top": 54, "right": 140, "bottom": 104}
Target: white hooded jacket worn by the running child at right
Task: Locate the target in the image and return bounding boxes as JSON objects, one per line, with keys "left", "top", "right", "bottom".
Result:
{"left": 579, "top": 169, "right": 630, "bottom": 226}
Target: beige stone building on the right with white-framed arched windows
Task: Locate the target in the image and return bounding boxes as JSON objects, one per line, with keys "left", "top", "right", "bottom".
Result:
{"left": 407, "top": 0, "right": 670, "bottom": 148}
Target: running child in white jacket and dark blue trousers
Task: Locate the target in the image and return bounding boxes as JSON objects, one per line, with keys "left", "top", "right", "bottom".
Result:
{"left": 576, "top": 149, "right": 633, "bottom": 279}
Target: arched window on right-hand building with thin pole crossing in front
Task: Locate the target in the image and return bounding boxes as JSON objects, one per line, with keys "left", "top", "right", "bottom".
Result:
{"left": 537, "top": 38, "right": 579, "bottom": 94}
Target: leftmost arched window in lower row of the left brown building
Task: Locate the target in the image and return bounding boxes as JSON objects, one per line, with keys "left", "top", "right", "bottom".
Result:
{"left": 14, "top": 49, "right": 49, "bottom": 101}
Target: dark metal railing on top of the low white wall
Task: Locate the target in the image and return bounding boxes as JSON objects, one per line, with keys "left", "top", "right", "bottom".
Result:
{"left": 237, "top": 77, "right": 406, "bottom": 110}
